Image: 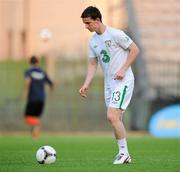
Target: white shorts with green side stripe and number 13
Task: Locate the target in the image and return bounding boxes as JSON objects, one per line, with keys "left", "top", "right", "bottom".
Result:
{"left": 104, "top": 80, "right": 134, "bottom": 111}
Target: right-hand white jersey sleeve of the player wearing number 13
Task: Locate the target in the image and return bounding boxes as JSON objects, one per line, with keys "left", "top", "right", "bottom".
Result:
{"left": 116, "top": 30, "right": 133, "bottom": 49}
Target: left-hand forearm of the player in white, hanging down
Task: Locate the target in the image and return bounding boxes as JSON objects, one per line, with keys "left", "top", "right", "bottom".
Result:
{"left": 79, "top": 58, "right": 98, "bottom": 97}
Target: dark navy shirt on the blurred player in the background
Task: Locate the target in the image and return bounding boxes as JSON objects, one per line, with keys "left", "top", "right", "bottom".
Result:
{"left": 25, "top": 67, "right": 53, "bottom": 102}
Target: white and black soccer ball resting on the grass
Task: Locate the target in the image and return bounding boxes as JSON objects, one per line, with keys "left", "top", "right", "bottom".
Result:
{"left": 36, "top": 146, "right": 56, "bottom": 164}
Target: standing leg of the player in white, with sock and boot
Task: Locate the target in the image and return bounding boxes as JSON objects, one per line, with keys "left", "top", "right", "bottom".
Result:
{"left": 107, "top": 108, "right": 131, "bottom": 164}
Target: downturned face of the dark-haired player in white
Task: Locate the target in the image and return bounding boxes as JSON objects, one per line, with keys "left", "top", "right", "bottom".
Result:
{"left": 82, "top": 17, "right": 98, "bottom": 32}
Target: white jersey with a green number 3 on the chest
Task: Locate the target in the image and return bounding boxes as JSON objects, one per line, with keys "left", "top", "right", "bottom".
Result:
{"left": 89, "top": 27, "right": 134, "bottom": 84}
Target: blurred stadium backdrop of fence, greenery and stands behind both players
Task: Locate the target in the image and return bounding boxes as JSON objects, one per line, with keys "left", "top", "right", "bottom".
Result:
{"left": 0, "top": 0, "right": 180, "bottom": 132}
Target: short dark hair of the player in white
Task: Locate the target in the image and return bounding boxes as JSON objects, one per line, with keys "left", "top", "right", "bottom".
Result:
{"left": 81, "top": 6, "right": 102, "bottom": 22}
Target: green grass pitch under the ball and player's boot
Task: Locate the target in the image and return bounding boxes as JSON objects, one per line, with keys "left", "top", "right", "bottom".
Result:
{"left": 0, "top": 135, "right": 180, "bottom": 172}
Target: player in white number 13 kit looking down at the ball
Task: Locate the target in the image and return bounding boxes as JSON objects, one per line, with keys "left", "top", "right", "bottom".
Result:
{"left": 79, "top": 6, "right": 139, "bottom": 164}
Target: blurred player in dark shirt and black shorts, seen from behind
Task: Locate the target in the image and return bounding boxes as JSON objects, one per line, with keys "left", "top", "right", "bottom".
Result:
{"left": 24, "top": 56, "right": 53, "bottom": 139}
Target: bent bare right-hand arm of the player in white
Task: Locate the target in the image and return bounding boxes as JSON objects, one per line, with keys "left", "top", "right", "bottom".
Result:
{"left": 114, "top": 42, "right": 139, "bottom": 80}
